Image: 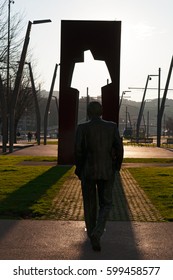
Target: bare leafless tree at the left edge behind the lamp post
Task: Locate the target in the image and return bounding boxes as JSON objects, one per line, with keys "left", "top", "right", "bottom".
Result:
{"left": 0, "top": 0, "right": 42, "bottom": 149}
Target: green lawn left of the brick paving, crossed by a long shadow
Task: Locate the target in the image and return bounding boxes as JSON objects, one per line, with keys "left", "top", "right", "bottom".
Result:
{"left": 0, "top": 166, "right": 73, "bottom": 219}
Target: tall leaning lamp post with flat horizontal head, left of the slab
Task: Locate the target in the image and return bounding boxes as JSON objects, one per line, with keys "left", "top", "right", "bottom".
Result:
{"left": 9, "top": 19, "right": 51, "bottom": 153}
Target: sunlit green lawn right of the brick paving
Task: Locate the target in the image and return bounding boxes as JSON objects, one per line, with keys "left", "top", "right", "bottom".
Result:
{"left": 129, "top": 167, "right": 173, "bottom": 221}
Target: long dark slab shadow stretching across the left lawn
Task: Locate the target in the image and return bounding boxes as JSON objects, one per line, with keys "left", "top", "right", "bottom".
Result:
{"left": 0, "top": 166, "right": 71, "bottom": 219}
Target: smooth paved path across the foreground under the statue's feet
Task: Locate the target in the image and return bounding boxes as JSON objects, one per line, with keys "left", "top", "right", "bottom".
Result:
{"left": 0, "top": 220, "right": 173, "bottom": 260}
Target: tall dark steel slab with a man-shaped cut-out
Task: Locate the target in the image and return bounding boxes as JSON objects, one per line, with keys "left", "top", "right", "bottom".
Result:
{"left": 58, "top": 20, "right": 121, "bottom": 165}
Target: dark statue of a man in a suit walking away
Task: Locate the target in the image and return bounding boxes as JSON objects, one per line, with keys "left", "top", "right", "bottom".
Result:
{"left": 75, "top": 101, "right": 123, "bottom": 251}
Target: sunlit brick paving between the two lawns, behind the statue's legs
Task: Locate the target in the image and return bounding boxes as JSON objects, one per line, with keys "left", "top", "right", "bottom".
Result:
{"left": 47, "top": 168, "right": 163, "bottom": 222}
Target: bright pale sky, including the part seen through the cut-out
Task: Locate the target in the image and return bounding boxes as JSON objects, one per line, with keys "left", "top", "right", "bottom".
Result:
{"left": 11, "top": 0, "right": 173, "bottom": 101}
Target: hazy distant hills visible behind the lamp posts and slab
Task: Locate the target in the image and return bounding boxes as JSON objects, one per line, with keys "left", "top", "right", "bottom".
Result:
{"left": 37, "top": 91, "right": 173, "bottom": 135}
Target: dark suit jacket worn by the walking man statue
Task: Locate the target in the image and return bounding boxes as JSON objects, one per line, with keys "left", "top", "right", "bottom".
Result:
{"left": 75, "top": 118, "right": 123, "bottom": 180}
